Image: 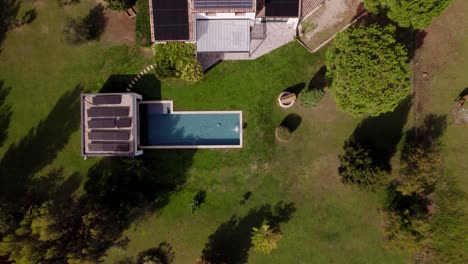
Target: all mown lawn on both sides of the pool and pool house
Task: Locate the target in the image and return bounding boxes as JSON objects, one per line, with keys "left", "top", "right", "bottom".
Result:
{"left": 0, "top": 0, "right": 414, "bottom": 263}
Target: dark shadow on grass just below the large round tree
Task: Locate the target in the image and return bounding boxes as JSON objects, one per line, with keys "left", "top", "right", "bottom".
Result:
{"left": 344, "top": 96, "right": 412, "bottom": 171}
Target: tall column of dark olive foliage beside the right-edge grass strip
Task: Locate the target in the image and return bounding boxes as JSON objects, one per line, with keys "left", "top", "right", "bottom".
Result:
{"left": 384, "top": 114, "right": 447, "bottom": 255}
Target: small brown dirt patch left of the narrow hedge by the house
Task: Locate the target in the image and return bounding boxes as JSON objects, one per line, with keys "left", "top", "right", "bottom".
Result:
{"left": 102, "top": 10, "right": 135, "bottom": 45}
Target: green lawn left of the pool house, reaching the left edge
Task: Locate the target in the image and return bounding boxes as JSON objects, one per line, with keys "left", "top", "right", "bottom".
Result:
{"left": 0, "top": 0, "right": 147, "bottom": 179}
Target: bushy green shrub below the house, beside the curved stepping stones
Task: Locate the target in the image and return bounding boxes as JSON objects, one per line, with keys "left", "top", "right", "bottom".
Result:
{"left": 154, "top": 42, "right": 203, "bottom": 81}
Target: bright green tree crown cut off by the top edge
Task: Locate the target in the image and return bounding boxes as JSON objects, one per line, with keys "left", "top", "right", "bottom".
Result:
{"left": 364, "top": 0, "right": 452, "bottom": 29}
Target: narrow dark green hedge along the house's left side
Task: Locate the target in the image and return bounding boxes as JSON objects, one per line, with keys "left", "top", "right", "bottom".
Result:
{"left": 135, "top": 0, "right": 151, "bottom": 46}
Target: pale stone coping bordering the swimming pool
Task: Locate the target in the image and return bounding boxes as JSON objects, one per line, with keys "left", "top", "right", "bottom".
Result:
{"left": 138, "top": 100, "right": 243, "bottom": 149}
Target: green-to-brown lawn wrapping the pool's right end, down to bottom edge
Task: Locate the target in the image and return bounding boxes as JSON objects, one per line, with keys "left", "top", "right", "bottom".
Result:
{"left": 104, "top": 43, "right": 407, "bottom": 263}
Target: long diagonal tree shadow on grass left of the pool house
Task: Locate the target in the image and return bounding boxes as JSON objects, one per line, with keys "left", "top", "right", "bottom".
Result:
{"left": 0, "top": 85, "right": 83, "bottom": 205}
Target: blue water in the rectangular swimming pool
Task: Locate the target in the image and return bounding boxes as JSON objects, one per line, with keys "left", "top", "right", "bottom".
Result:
{"left": 147, "top": 109, "right": 241, "bottom": 146}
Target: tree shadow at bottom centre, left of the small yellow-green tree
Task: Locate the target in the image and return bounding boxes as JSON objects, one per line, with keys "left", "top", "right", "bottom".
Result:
{"left": 202, "top": 202, "right": 296, "bottom": 264}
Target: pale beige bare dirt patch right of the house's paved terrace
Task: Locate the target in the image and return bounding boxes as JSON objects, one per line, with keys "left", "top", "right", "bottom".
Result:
{"left": 300, "top": 0, "right": 362, "bottom": 50}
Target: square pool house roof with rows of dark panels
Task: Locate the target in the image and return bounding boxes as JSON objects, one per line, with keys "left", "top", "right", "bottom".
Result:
{"left": 81, "top": 93, "right": 143, "bottom": 157}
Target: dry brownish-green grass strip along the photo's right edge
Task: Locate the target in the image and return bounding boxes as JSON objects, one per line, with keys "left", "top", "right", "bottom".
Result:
{"left": 416, "top": 0, "right": 468, "bottom": 263}
